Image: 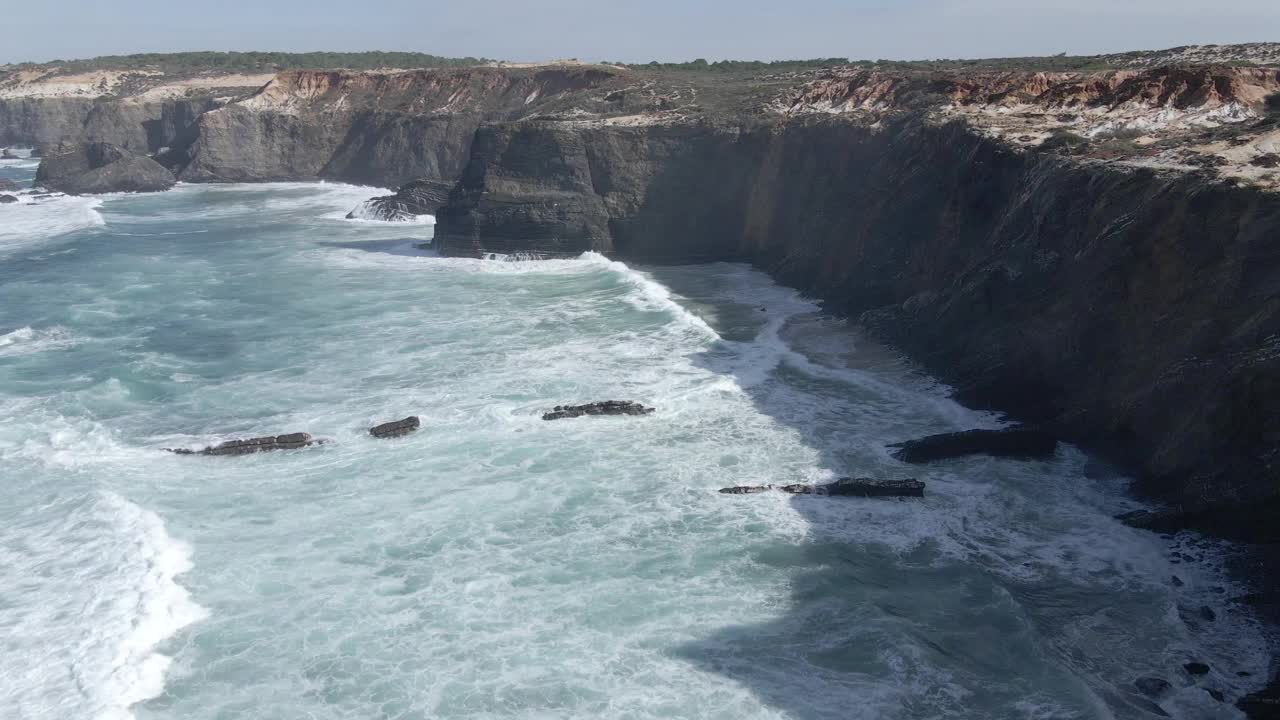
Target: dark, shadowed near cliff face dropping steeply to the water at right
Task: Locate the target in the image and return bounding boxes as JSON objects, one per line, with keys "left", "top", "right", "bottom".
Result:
{"left": 436, "top": 117, "right": 1280, "bottom": 539}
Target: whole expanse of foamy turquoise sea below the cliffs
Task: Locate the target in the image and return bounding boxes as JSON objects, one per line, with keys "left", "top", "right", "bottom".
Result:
{"left": 0, "top": 156, "right": 1266, "bottom": 719}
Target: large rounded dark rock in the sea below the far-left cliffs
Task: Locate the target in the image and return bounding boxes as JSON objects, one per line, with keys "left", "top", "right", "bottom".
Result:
{"left": 36, "top": 142, "right": 177, "bottom": 195}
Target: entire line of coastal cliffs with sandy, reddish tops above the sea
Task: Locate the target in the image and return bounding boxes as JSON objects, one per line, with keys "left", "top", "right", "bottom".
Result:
{"left": 0, "top": 49, "right": 1280, "bottom": 712}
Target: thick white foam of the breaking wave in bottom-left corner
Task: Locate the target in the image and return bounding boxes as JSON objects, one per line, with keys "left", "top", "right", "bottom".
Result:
{"left": 0, "top": 492, "right": 206, "bottom": 720}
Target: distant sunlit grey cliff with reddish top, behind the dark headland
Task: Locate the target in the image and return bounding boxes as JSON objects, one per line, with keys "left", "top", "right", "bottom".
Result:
{"left": 180, "top": 68, "right": 613, "bottom": 186}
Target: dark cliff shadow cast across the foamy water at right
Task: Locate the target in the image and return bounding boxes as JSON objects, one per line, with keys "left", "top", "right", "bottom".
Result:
{"left": 634, "top": 268, "right": 1223, "bottom": 720}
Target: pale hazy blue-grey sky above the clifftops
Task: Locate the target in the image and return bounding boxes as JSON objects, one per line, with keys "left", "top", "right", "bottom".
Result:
{"left": 0, "top": 0, "right": 1280, "bottom": 63}
